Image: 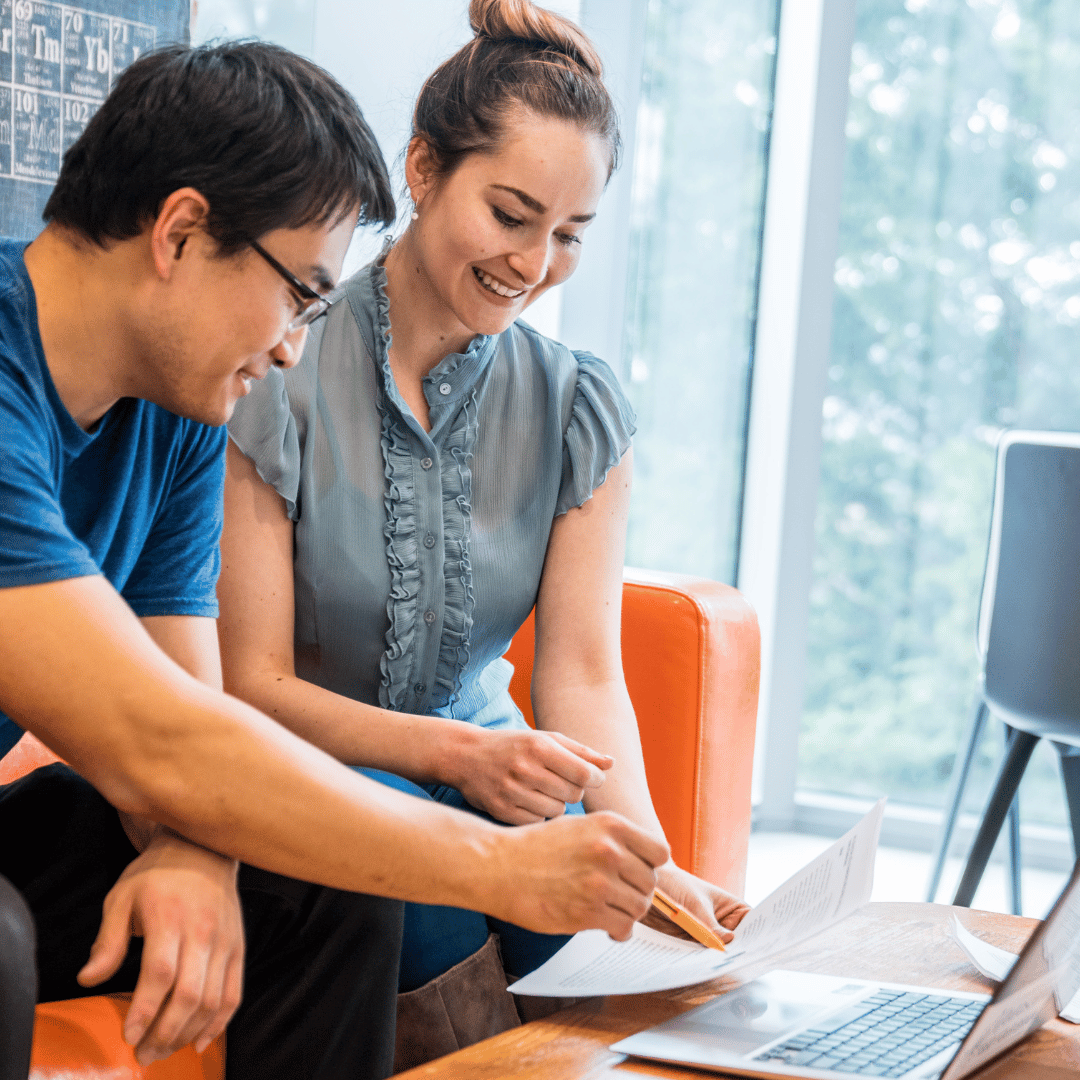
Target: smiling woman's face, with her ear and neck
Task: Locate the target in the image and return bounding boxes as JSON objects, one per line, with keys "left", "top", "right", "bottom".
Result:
{"left": 386, "top": 108, "right": 610, "bottom": 406}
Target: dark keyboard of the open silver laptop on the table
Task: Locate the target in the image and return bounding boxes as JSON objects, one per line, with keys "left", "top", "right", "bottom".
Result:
{"left": 754, "top": 990, "right": 986, "bottom": 1077}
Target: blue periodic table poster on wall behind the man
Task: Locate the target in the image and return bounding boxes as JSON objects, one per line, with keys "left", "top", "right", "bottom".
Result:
{"left": 0, "top": 0, "right": 190, "bottom": 240}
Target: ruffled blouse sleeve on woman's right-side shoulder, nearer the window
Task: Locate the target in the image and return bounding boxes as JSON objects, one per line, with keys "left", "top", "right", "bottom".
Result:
{"left": 555, "top": 352, "right": 636, "bottom": 517}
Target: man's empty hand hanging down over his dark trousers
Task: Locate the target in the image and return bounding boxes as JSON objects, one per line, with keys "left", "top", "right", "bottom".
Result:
{"left": 78, "top": 829, "right": 244, "bottom": 1065}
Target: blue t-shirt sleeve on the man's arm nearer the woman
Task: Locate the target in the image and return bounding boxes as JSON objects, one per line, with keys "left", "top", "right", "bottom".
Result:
{"left": 121, "top": 421, "right": 226, "bottom": 619}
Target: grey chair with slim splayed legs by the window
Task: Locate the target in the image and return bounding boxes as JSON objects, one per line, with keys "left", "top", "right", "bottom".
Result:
{"left": 928, "top": 431, "right": 1080, "bottom": 914}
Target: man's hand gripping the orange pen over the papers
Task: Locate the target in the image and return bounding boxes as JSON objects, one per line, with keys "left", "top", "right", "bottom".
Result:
{"left": 494, "top": 810, "right": 671, "bottom": 941}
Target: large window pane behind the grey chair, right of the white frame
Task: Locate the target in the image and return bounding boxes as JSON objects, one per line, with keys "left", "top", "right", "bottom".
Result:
{"left": 799, "top": 0, "right": 1080, "bottom": 820}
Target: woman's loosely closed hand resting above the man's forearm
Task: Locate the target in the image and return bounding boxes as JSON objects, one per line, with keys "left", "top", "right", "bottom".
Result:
{"left": 438, "top": 724, "right": 615, "bottom": 825}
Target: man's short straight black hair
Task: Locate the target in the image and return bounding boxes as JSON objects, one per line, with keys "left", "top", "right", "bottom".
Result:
{"left": 42, "top": 41, "right": 395, "bottom": 255}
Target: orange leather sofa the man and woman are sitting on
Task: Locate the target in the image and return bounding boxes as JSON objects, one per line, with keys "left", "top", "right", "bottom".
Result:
{"left": 0, "top": 570, "right": 759, "bottom": 1080}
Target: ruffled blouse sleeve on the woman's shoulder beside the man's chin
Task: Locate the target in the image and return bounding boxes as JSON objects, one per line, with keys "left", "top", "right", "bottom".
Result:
{"left": 229, "top": 365, "right": 302, "bottom": 522}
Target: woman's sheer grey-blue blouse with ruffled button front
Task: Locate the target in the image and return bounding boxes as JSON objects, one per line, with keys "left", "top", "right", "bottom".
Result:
{"left": 229, "top": 251, "right": 634, "bottom": 727}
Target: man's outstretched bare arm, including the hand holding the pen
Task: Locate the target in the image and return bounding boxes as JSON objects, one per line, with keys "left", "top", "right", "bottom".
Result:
{"left": 0, "top": 577, "right": 667, "bottom": 939}
